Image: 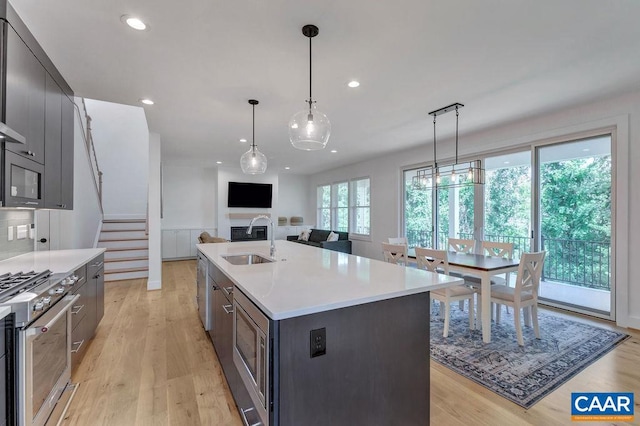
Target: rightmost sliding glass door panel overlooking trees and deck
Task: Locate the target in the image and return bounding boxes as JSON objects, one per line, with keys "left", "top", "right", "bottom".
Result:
{"left": 535, "top": 135, "right": 613, "bottom": 316}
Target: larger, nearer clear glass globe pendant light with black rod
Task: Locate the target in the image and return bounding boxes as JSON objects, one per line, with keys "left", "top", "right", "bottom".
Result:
{"left": 289, "top": 25, "right": 331, "bottom": 151}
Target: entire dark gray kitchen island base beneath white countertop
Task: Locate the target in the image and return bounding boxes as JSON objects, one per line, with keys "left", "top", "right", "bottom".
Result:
{"left": 208, "top": 262, "right": 429, "bottom": 426}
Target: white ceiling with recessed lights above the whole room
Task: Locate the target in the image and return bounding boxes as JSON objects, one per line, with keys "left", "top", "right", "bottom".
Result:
{"left": 12, "top": 0, "right": 640, "bottom": 174}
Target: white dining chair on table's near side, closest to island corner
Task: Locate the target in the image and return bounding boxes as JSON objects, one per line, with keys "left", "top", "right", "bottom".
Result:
{"left": 415, "top": 247, "right": 475, "bottom": 337}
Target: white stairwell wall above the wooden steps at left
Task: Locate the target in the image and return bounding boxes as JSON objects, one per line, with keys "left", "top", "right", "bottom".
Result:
{"left": 86, "top": 99, "right": 149, "bottom": 219}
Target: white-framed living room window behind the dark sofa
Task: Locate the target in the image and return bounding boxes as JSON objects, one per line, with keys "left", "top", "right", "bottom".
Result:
{"left": 317, "top": 178, "right": 371, "bottom": 235}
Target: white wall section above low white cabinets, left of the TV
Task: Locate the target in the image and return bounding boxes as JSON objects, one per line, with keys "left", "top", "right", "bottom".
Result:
{"left": 162, "top": 164, "right": 218, "bottom": 229}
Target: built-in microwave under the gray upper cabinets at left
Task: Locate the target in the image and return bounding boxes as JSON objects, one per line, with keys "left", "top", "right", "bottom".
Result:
{"left": 2, "top": 149, "right": 44, "bottom": 208}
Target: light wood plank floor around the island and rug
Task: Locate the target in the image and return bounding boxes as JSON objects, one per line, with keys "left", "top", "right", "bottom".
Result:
{"left": 63, "top": 261, "right": 640, "bottom": 426}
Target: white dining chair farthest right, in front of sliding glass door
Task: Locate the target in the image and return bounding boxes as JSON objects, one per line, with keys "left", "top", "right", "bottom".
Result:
{"left": 491, "top": 251, "right": 545, "bottom": 346}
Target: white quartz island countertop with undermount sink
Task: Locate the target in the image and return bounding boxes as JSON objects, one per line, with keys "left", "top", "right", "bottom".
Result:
{"left": 197, "top": 240, "right": 463, "bottom": 320}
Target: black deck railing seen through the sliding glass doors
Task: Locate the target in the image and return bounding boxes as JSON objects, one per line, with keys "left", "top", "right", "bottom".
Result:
{"left": 407, "top": 231, "right": 611, "bottom": 291}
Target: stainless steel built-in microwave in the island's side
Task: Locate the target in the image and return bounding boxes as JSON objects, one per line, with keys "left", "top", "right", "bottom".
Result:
{"left": 233, "top": 291, "right": 271, "bottom": 426}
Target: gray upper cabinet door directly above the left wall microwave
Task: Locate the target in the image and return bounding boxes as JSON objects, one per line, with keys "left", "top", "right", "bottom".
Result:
{"left": 5, "top": 24, "right": 46, "bottom": 164}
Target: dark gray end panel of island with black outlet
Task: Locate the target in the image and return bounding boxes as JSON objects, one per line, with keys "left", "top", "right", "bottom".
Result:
{"left": 273, "top": 293, "right": 429, "bottom": 426}
